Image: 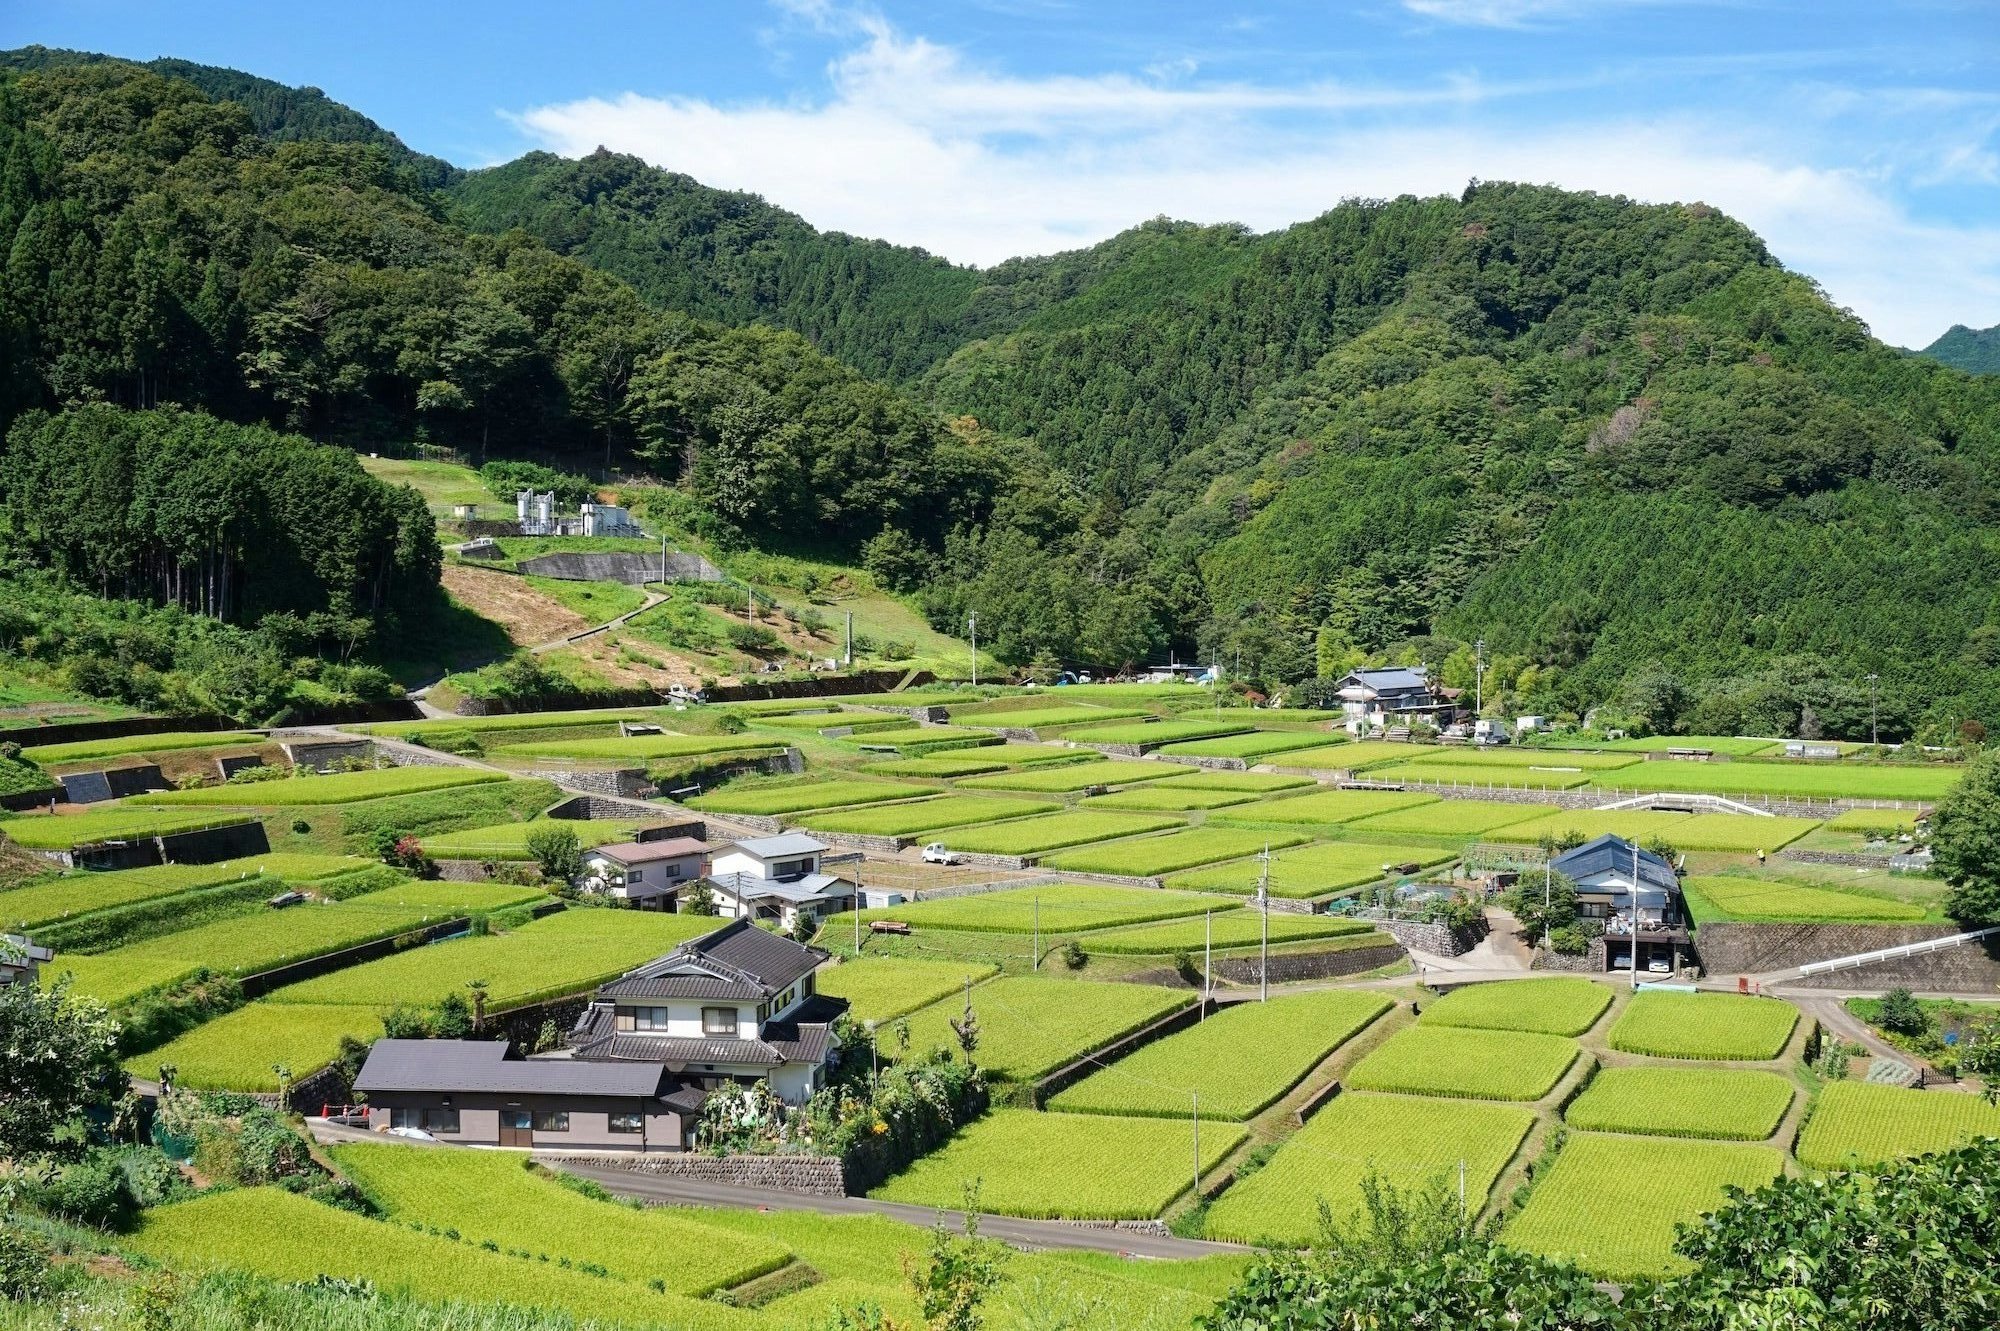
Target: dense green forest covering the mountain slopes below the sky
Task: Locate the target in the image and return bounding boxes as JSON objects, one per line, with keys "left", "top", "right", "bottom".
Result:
{"left": 0, "top": 50, "right": 2000, "bottom": 737}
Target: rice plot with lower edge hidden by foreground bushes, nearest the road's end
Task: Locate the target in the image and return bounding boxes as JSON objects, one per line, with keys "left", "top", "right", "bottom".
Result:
{"left": 1208, "top": 1093, "right": 1534, "bottom": 1247}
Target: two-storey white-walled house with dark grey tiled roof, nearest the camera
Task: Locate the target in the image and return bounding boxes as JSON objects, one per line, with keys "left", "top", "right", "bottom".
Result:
{"left": 570, "top": 919, "right": 846, "bottom": 1105}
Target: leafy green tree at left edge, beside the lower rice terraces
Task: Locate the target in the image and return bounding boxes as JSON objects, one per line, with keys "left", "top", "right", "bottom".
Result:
{"left": 0, "top": 979, "right": 130, "bottom": 1159}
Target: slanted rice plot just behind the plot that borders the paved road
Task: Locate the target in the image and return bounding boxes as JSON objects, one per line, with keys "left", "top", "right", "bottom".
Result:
{"left": 1048, "top": 989, "right": 1394, "bottom": 1123}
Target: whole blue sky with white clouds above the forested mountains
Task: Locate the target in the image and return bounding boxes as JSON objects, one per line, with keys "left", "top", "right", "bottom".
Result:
{"left": 0, "top": 0, "right": 2000, "bottom": 346}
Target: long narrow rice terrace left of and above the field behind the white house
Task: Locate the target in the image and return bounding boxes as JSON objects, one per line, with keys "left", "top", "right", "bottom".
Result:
{"left": 50, "top": 883, "right": 546, "bottom": 1003}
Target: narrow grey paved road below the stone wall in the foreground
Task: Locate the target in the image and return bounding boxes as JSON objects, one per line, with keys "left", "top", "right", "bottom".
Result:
{"left": 548, "top": 1161, "right": 1246, "bottom": 1257}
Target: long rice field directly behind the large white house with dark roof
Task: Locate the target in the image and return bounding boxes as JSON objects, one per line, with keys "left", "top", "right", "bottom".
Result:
{"left": 262, "top": 909, "right": 724, "bottom": 1011}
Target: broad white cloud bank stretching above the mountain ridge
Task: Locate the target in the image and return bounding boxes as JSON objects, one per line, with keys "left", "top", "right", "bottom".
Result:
{"left": 516, "top": 15, "right": 2000, "bottom": 346}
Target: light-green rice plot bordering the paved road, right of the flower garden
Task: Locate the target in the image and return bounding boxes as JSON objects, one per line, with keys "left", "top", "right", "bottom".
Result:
{"left": 870, "top": 1109, "right": 1244, "bottom": 1219}
